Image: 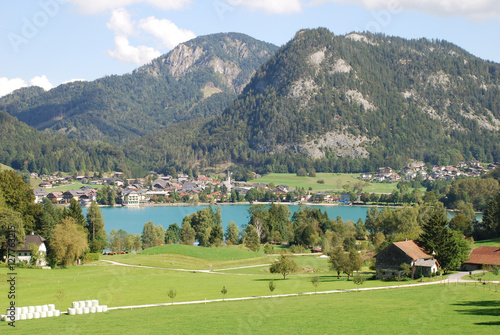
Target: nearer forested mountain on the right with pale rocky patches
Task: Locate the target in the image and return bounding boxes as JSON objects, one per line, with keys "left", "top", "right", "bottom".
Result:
{"left": 127, "top": 28, "right": 500, "bottom": 172}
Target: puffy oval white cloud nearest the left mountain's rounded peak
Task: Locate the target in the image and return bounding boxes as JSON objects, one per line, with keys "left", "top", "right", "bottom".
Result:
{"left": 139, "top": 16, "right": 196, "bottom": 49}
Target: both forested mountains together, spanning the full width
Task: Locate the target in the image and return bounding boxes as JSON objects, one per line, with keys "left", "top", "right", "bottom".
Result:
{"left": 0, "top": 28, "right": 500, "bottom": 177}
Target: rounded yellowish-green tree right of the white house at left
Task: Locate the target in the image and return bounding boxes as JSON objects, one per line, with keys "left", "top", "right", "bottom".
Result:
{"left": 51, "top": 217, "right": 88, "bottom": 267}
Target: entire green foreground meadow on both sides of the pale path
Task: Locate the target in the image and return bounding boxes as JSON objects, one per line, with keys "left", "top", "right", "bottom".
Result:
{"left": 0, "top": 245, "right": 500, "bottom": 334}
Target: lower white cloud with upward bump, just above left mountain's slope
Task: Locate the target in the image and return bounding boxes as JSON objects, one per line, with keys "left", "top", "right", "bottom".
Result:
{"left": 106, "top": 36, "right": 161, "bottom": 65}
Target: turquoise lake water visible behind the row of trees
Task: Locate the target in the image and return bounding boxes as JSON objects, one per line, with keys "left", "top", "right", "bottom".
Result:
{"left": 84, "top": 205, "right": 481, "bottom": 234}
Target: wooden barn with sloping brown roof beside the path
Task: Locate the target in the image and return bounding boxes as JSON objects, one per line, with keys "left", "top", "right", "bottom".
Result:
{"left": 376, "top": 241, "right": 439, "bottom": 279}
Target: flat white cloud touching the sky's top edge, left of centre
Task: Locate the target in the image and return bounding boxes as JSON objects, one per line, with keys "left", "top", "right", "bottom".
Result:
{"left": 66, "top": 0, "right": 191, "bottom": 14}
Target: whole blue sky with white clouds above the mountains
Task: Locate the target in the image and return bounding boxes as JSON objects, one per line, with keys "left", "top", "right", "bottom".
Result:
{"left": 0, "top": 0, "right": 500, "bottom": 96}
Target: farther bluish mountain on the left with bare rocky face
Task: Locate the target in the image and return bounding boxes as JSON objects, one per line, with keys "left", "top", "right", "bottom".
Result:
{"left": 0, "top": 33, "right": 277, "bottom": 145}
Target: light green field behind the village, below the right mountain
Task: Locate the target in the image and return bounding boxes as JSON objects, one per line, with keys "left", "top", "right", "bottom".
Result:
{"left": 252, "top": 173, "right": 396, "bottom": 193}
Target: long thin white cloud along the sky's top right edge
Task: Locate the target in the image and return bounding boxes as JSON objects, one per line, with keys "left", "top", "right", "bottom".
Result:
{"left": 309, "top": 0, "right": 500, "bottom": 20}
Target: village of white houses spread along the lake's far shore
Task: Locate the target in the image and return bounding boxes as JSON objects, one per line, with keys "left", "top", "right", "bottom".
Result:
{"left": 30, "top": 161, "right": 498, "bottom": 207}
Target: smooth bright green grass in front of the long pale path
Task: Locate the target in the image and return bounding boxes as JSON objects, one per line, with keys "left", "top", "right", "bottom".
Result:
{"left": 0, "top": 285, "right": 500, "bottom": 334}
